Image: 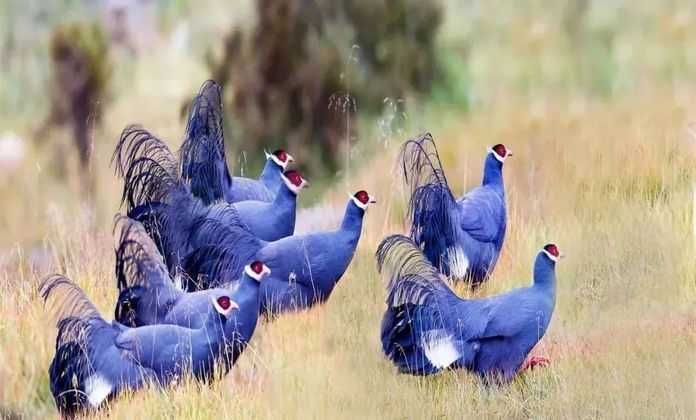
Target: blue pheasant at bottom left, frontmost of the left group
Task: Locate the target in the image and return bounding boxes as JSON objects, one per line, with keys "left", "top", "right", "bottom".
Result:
{"left": 44, "top": 275, "right": 238, "bottom": 416}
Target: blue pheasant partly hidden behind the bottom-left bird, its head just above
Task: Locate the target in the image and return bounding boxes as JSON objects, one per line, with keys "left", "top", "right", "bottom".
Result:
{"left": 114, "top": 216, "right": 270, "bottom": 372}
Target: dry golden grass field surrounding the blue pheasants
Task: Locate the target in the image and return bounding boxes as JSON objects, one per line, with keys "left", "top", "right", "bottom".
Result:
{"left": 0, "top": 2, "right": 696, "bottom": 419}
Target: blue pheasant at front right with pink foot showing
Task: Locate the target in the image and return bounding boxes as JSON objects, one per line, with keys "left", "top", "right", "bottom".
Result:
{"left": 377, "top": 235, "right": 561, "bottom": 382}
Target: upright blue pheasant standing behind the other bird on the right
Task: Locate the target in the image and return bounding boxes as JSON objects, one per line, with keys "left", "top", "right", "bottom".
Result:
{"left": 399, "top": 133, "right": 512, "bottom": 285}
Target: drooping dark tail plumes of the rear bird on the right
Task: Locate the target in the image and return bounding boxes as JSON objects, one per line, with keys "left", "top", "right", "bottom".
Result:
{"left": 400, "top": 133, "right": 456, "bottom": 274}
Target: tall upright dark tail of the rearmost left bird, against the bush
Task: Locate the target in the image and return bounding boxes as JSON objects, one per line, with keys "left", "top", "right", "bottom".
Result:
{"left": 179, "top": 80, "right": 232, "bottom": 204}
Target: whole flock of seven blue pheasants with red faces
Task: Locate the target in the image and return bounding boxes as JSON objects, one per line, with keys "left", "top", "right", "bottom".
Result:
{"left": 40, "top": 81, "right": 561, "bottom": 416}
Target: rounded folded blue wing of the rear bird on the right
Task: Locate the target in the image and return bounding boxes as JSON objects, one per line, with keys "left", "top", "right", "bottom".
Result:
{"left": 457, "top": 187, "right": 504, "bottom": 242}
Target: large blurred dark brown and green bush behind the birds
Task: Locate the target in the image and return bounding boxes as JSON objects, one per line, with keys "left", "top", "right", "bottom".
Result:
{"left": 209, "top": 0, "right": 442, "bottom": 175}
